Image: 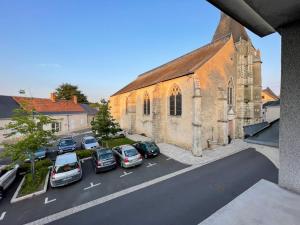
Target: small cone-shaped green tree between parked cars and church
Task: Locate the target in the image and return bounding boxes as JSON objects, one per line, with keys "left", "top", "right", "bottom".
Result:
{"left": 91, "top": 99, "right": 120, "bottom": 142}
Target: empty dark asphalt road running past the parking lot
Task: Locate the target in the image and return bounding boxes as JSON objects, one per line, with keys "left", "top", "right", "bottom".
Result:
{"left": 47, "top": 149, "right": 278, "bottom": 225}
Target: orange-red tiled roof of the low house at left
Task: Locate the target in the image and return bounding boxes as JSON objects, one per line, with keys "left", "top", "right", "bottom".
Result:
{"left": 13, "top": 97, "right": 84, "bottom": 113}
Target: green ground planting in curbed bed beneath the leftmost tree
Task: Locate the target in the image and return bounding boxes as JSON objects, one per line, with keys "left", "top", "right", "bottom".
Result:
{"left": 18, "top": 167, "right": 49, "bottom": 197}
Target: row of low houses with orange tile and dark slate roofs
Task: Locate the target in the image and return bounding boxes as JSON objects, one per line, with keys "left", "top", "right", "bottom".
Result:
{"left": 0, "top": 93, "right": 95, "bottom": 143}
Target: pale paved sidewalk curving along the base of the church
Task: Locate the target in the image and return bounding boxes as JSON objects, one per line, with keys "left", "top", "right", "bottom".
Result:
{"left": 127, "top": 134, "right": 279, "bottom": 168}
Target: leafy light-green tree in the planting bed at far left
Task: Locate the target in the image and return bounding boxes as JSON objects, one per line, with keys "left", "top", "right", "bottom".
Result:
{"left": 1, "top": 109, "right": 55, "bottom": 179}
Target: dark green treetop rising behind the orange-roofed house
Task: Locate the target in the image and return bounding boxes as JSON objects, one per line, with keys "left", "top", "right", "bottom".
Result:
{"left": 56, "top": 83, "right": 89, "bottom": 104}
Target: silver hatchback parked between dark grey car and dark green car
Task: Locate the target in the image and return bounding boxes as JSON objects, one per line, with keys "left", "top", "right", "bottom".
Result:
{"left": 113, "top": 145, "right": 143, "bottom": 168}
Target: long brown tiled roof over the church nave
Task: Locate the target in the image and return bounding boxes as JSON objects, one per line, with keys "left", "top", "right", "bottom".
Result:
{"left": 113, "top": 36, "right": 229, "bottom": 96}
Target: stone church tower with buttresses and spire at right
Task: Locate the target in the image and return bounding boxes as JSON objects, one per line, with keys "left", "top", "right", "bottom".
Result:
{"left": 212, "top": 13, "right": 262, "bottom": 138}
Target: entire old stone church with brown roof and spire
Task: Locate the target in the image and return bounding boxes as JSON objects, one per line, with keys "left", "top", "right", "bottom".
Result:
{"left": 110, "top": 14, "right": 261, "bottom": 156}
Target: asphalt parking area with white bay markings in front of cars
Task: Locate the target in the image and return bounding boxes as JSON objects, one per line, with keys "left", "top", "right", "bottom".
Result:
{"left": 0, "top": 154, "right": 187, "bottom": 224}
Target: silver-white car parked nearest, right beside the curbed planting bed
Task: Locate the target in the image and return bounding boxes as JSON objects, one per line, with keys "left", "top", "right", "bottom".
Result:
{"left": 50, "top": 153, "right": 82, "bottom": 187}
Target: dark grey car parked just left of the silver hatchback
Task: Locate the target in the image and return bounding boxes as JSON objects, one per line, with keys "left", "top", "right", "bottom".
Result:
{"left": 92, "top": 148, "right": 117, "bottom": 173}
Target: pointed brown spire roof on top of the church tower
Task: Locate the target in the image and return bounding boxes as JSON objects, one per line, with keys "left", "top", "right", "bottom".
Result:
{"left": 212, "top": 13, "right": 250, "bottom": 42}
